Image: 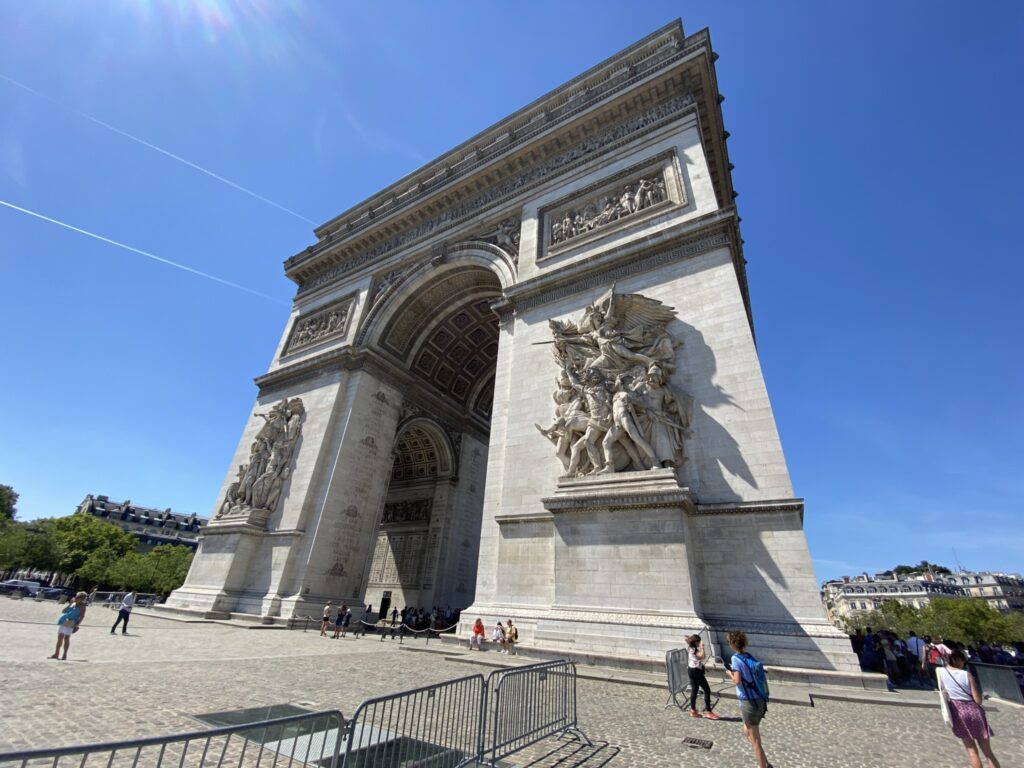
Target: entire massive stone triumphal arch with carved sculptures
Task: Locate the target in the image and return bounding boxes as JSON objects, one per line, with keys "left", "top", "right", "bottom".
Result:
{"left": 168, "top": 23, "right": 856, "bottom": 673}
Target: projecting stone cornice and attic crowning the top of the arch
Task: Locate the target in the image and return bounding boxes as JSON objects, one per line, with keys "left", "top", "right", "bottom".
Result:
{"left": 285, "top": 22, "right": 732, "bottom": 294}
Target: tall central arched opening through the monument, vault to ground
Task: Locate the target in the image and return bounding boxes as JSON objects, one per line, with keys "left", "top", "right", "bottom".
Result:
{"left": 365, "top": 262, "right": 501, "bottom": 614}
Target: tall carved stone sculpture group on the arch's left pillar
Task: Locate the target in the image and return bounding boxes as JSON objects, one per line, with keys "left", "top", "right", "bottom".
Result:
{"left": 216, "top": 397, "right": 305, "bottom": 522}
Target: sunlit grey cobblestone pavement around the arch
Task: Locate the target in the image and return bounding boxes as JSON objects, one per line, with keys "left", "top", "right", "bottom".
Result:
{"left": 0, "top": 597, "right": 1024, "bottom": 768}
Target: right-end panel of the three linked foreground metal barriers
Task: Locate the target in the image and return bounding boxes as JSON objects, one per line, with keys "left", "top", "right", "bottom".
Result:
{"left": 480, "top": 660, "right": 592, "bottom": 766}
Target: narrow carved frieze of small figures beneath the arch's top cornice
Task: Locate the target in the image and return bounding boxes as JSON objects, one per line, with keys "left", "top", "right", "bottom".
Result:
{"left": 298, "top": 92, "right": 695, "bottom": 296}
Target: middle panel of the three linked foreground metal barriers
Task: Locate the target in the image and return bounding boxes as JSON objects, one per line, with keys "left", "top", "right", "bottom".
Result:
{"left": 344, "top": 675, "right": 485, "bottom": 768}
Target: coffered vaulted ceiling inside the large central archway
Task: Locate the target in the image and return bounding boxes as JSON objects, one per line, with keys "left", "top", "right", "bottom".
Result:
{"left": 381, "top": 268, "right": 501, "bottom": 421}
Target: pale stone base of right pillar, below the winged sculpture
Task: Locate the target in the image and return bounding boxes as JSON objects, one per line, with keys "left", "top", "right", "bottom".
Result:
{"left": 460, "top": 469, "right": 864, "bottom": 687}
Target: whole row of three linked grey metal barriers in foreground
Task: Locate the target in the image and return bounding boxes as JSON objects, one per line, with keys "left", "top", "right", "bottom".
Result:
{"left": 0, "top": 660, "right": 593, "bottom": 768}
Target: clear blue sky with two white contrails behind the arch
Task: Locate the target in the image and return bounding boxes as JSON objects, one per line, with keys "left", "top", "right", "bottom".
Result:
{"left": 0, "top": 0, "right": 1024, "bottom": 579}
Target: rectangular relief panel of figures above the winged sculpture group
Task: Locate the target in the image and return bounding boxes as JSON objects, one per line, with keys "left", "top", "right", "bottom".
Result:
{"left": 548, "top": 170, "right": 669, "bottom": 246}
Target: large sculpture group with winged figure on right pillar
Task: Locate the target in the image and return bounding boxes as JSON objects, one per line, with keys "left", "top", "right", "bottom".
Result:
{"left": 535, "top": 286, "right": 692, "bottom": 476}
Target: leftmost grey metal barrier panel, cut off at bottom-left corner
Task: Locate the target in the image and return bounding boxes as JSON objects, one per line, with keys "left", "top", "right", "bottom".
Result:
{"left": 0, "top": 711, "right": 345, "bottom": 768}
